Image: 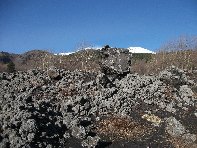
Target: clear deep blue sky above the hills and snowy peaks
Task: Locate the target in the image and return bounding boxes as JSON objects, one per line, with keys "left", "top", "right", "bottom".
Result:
{"left": 0, "top": 0, "right": 197, "bottom": 53}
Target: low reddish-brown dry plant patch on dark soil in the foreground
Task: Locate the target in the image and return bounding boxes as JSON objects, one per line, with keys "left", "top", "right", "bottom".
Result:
{"left": 97, "top": 116, "right": 154, "bottom": 141}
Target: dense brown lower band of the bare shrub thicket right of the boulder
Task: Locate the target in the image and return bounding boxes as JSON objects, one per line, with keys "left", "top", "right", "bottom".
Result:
{"left": 131, "top": 50, "right": 197, "bottom": 74}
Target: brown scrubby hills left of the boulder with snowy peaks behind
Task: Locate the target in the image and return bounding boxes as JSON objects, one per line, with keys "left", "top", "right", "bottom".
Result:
{"left": 0, "top": 45, "right": 154, "bottom": 72}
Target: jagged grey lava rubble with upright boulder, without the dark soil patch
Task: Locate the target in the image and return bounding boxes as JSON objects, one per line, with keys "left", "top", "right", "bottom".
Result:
{"left": 0, "top": 64, "right": 197, "bottom": 147}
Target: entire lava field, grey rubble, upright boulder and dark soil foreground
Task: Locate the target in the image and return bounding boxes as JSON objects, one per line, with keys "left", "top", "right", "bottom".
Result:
{"left": 0, "top": 49, "right": 197, "bottom": 148}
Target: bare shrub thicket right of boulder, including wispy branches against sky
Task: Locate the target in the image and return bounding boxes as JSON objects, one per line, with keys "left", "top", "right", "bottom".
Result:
{"left": 131, "top": 37, "right": 197, "bottom": 74}
